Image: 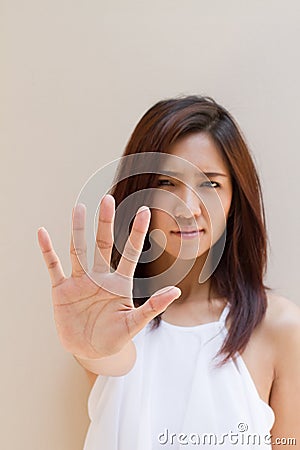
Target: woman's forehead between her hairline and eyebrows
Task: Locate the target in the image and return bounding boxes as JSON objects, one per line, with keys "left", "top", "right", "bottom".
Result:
{"left": 163, "top": 132, "right": 229, "bottom": 174}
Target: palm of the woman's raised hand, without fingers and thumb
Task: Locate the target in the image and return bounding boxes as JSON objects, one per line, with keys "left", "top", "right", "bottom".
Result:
{"left": 52, "top": 274, "right": 133, "bottom": 358}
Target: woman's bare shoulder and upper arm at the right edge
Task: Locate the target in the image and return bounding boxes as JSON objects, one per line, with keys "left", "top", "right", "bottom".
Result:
{"left": 265, "top": 294, "right": 300, "bottom": 440}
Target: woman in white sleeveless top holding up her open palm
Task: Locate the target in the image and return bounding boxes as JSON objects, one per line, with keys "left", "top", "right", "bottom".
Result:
{"left": 38, "top": 96, "right": 300, "bottom": 450}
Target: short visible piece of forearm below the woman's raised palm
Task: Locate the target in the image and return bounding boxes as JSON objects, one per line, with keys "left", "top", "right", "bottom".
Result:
{"left": 73, "top": 341, "right": 136, "bottom": 377}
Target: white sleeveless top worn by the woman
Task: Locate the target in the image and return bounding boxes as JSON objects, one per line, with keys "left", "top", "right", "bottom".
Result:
{"left": 84, "top": 304, "right": 275, "bottom": 450}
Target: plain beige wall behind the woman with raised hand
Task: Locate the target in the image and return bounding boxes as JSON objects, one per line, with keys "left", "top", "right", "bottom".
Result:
{"left": 0, "top": 0, "right": 300, "bottom": 450}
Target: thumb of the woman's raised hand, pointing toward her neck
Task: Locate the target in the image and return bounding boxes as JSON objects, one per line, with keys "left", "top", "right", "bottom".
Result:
{"left": 132, "top": 286, "right": 181, "bottom": 334}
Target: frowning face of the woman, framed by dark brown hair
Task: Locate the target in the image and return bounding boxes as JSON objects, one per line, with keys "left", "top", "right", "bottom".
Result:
{"left": 149, "top": 132, "right": 232, "bottom": 260}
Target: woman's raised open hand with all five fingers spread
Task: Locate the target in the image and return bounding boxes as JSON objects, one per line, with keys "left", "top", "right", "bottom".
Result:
{"left": 38, "top": 195, "right": 181, "bottom": 358}
